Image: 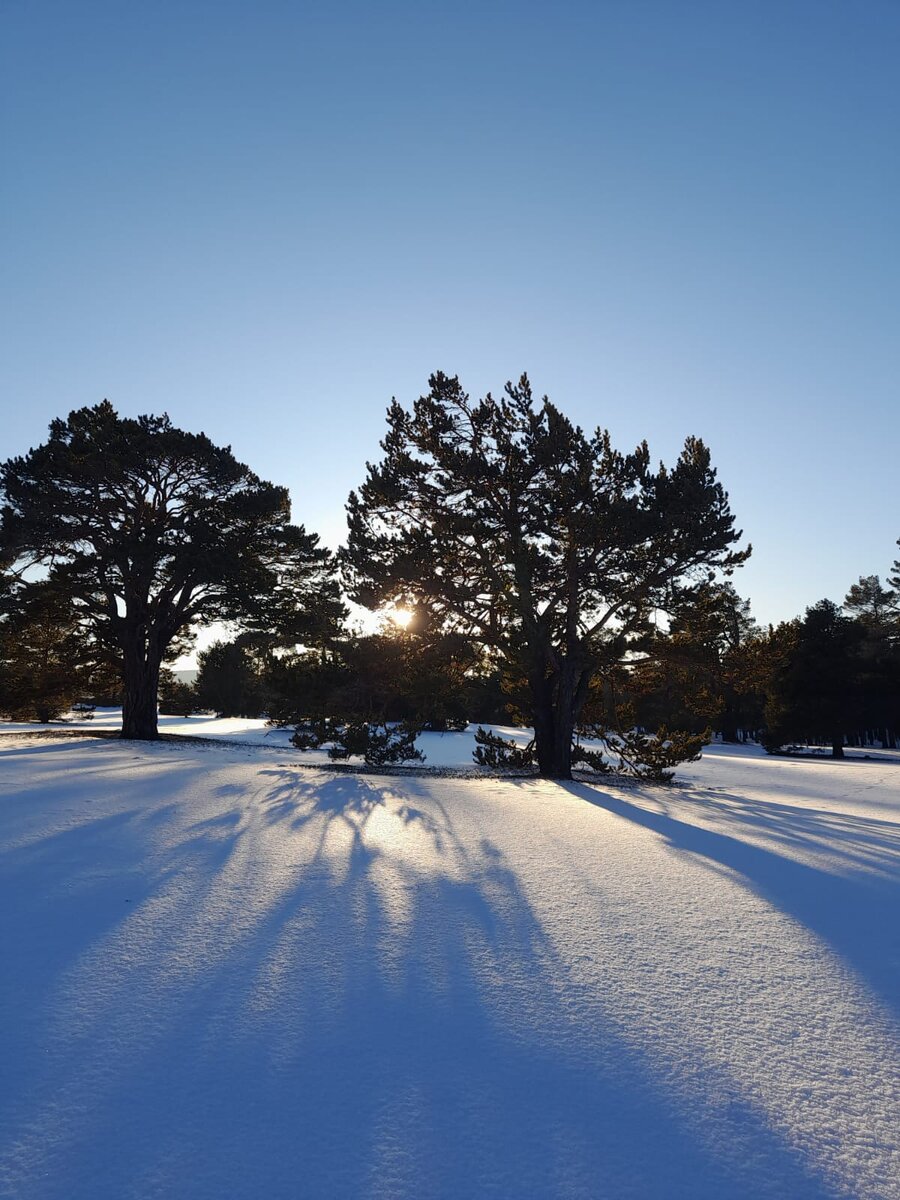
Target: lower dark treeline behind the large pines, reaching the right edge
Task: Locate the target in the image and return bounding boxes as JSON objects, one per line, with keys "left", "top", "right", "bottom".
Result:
{"left": 148, "top": 575, "right": 900, "bottom": 757}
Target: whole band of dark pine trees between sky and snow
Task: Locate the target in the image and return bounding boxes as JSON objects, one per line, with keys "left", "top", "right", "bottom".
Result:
{"left": 0, "top": 386, "right": 900, "bottom": 780}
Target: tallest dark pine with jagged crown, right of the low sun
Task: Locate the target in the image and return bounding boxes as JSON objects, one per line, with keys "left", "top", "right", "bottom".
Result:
{"left": 343, "top": 374, "right": 749, "bottom": 779}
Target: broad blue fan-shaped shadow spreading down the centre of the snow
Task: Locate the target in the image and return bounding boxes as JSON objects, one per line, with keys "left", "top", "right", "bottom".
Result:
{"left": 0, "top": 770, "right": 839, "bottom": 1200}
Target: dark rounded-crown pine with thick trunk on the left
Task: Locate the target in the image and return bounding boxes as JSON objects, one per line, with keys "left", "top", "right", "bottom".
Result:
{"left": 0, "top": 401, "right": 341, "bottom": 738}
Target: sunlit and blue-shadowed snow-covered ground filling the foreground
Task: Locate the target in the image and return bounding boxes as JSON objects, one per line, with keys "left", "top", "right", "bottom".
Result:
{"left": 0, "top": 718, "right": 900, "bottom": 1200}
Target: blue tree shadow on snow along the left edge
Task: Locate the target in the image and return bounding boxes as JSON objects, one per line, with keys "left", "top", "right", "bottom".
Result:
{"left": 0, "top": 743, "right": 247, "bottom": 1137}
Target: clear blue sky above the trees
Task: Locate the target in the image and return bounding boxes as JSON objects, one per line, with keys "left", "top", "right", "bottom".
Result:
{"left": 0, "top": 0, "right": 900, "bottom": 620}
